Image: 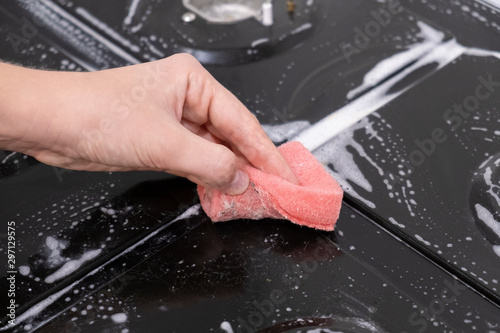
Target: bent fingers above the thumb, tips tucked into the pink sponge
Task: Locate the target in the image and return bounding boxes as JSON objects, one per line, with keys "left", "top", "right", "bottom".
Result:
{"left": 178, "top": 53, "right": 298, "bottom": 184}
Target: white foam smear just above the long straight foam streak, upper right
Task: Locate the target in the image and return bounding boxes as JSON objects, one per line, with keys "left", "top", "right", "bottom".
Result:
{"left": 347, "top": 21, "right": 444, "bottom": 99}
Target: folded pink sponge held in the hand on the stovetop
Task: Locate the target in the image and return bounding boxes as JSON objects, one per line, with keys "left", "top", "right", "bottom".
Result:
{"left": 198, "top": 141, "right": 343, "bottom": 230}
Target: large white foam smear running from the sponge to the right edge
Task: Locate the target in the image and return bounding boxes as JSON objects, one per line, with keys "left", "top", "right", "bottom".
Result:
{"left": 263, "top": 22, "right": 500, "bottom": 216}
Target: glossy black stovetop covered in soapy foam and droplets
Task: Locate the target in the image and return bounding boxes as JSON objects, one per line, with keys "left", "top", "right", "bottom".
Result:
{"left": 0, "top": 0, "right": 500, "bottom": 332}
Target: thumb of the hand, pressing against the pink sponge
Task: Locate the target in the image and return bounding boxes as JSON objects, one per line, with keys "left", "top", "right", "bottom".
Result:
{"left": 174, "top": 127, "right": 249, "bottom": 195}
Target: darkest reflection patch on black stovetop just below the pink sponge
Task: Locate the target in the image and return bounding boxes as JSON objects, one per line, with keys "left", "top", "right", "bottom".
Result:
{"left": 119, "top": 217, "right": 342, "bottom": 306}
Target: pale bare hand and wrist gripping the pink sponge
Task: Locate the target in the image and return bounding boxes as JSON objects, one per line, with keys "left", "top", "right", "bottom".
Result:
{"left": 0, "top": 54, "right": 297, "bottom": 195}
